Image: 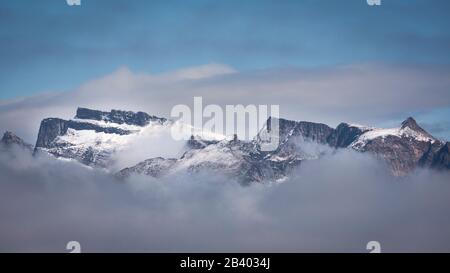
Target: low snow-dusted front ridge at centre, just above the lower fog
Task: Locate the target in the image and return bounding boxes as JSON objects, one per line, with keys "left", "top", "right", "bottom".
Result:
{"left": 117, "top": 139, "right": 300, "bottom": 184}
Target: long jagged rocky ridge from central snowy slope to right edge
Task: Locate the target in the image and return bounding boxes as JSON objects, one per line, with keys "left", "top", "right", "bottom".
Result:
{"left": 119, "top": 118, "right": 449, "bottom": 184}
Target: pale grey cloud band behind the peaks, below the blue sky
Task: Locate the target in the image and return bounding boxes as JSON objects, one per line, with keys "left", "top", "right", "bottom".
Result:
{"left": 0, "top": 64, "right": 450, "bottom": 142}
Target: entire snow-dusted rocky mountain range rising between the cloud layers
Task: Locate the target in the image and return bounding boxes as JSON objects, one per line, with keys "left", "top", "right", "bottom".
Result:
{"left": 0, "top": 108, "right": 450, "bottom": 184}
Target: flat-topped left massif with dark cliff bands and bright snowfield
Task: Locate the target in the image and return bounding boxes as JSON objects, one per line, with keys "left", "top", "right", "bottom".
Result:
{"left": 35, "top": 108, "right": 167, "bottom": 168}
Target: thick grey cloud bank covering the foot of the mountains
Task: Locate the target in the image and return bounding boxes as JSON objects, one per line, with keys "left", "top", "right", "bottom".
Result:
{"left": 0, "top": 144, "right": 450, "bottom": 252}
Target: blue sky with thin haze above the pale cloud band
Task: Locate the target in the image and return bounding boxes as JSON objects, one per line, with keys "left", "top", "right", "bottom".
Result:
{"left": 0, "top": 0, "right": 450, "bottom": 99}
